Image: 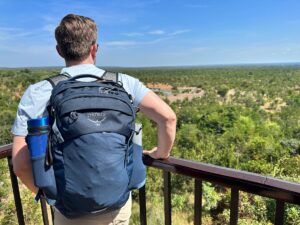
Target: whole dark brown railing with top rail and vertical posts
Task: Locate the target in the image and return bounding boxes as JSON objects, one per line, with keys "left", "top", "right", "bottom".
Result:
{"left": 0, "top": 145, "right": 300, "bottom": 225}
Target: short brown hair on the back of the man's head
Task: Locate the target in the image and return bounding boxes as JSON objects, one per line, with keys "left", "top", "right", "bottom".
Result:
{"left": 55, "top": 14, "right": 97, "bottom": 61}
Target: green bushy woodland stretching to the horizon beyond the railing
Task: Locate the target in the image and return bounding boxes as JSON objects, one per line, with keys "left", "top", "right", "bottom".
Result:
{"left": 0, "top": 65, "right": 300, "bottom": 225}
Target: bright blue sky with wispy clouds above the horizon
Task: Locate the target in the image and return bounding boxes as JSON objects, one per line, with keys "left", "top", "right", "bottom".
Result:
{"left": 0, "top": 0, "right": 300, "bottom": 67}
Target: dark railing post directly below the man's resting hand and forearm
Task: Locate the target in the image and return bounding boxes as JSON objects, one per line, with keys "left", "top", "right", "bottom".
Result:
{"left": 164, "top": 171, "right": 172, "bottom": 225}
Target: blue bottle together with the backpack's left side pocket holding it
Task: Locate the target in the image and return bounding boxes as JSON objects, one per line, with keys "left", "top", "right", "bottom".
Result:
{"left": 26, "top": 117, "right": 57, "bottom": 199}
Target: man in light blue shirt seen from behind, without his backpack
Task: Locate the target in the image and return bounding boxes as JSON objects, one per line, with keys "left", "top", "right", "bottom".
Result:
{"left": 12, "top": 14, "right": 176, "bottom": 225}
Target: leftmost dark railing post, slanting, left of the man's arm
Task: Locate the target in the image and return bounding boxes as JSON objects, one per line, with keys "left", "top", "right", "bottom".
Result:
{"left": 7, "top": 157, "right": 25, "bottom": 225}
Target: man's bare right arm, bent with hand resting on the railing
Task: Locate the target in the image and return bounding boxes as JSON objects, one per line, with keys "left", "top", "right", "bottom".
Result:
{"left": 139, "top": 91, "right": 176, "bottom": 159}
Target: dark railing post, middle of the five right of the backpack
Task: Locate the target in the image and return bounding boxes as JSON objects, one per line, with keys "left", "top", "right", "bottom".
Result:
{"left": 194, "top": 179, "right": 202, "bottom": 225}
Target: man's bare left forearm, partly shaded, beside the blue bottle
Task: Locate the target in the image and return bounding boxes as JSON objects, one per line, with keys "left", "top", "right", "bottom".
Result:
{"left": 12, "top": 136, "right": 38, "bottom": 193}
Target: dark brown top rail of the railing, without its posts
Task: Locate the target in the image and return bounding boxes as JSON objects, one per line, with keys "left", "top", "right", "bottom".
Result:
{"left": 0, "top": 144, "right": 300, "bottom": 205}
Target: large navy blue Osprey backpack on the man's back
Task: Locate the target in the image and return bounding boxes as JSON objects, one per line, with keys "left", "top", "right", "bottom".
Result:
{"left": 41, "top": 72, "right": 145, "bottom": 218}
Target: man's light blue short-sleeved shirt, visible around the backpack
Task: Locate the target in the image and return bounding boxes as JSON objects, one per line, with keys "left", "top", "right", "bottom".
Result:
{"left": 11, "top": 64, "right": 150, "bottom": 136}
